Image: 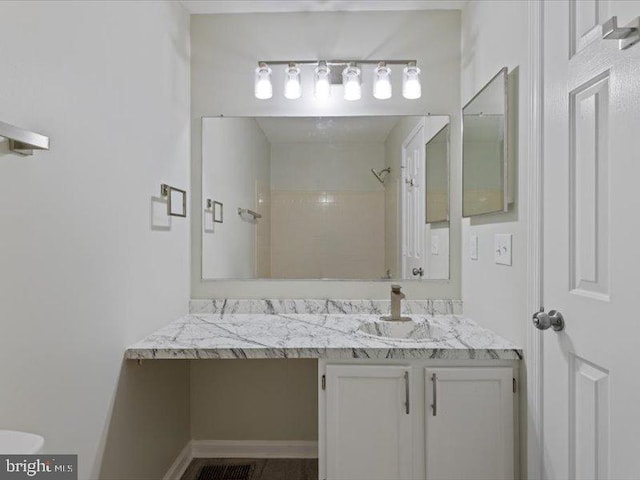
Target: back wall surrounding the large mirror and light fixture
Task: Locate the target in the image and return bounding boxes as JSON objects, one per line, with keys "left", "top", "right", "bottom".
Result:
{"left": 191, "top": 10, "right": 461, "bottom": 298}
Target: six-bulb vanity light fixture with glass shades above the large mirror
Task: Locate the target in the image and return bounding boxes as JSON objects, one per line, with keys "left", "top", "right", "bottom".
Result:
{"left": 254, "top": 60, "right": 422, "bottom": 101}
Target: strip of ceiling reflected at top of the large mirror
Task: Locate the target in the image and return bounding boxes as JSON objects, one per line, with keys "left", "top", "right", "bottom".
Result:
{"left": 256, "top": 116, "right": 404, "bottom": 143}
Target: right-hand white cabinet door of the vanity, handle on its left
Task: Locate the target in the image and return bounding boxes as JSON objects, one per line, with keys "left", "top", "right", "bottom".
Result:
{"left": 425, "top": 367, "right": 514, "bottom": 480}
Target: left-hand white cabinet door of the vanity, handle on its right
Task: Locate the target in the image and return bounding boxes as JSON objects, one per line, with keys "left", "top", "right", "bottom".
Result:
{"left": 326, "top": 365, "right": 413, "bottom": 480}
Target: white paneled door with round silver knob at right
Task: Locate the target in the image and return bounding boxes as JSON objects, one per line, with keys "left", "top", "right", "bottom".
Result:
{"left": 542, "top": 0, "right": 640, "bottom": 480}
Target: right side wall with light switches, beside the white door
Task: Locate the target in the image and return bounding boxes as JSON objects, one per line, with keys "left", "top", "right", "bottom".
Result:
{"left": 462, "top": 1, "right": 531, "bottom": 346}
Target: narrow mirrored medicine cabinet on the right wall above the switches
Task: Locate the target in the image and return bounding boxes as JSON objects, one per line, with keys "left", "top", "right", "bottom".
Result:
{"left": 462, "top": 68, "right": 510, "bottom": 217}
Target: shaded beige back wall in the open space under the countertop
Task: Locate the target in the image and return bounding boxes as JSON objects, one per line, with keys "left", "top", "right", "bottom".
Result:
{"left": 191, "top": 359, "right": 318, "bottom": 442}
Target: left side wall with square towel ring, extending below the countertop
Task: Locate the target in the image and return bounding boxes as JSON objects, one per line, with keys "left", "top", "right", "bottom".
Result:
{"left": 0, "top": 2, "right": 190, "bottom": 480}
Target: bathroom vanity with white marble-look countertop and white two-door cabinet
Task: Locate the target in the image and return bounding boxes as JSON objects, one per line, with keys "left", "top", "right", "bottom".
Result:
{"left": 125, "top": 300, "right": 521, "bottom": 480}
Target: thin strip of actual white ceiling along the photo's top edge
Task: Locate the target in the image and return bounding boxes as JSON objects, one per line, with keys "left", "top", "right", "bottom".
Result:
{"left": 181, "top": 0, "right": 466, "bottom": 14}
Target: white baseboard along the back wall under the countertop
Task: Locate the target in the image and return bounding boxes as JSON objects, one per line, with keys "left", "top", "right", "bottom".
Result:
{"left": 191, "top": 440, "right": 318, "bottom": 458}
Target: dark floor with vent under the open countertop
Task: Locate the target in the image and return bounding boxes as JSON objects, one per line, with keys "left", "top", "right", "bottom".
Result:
{"left": 181, "top": 458, "right": 318, "bottom": 480}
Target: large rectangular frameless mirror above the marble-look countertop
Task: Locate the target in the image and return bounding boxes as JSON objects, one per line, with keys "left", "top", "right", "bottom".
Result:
{"left": 202, "top": 115, "right": 450, "bottom": 281}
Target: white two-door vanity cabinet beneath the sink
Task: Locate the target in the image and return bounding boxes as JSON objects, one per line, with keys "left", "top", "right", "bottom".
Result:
{"left": 319, "top": 360, "right": 518, "bottom": 480}
